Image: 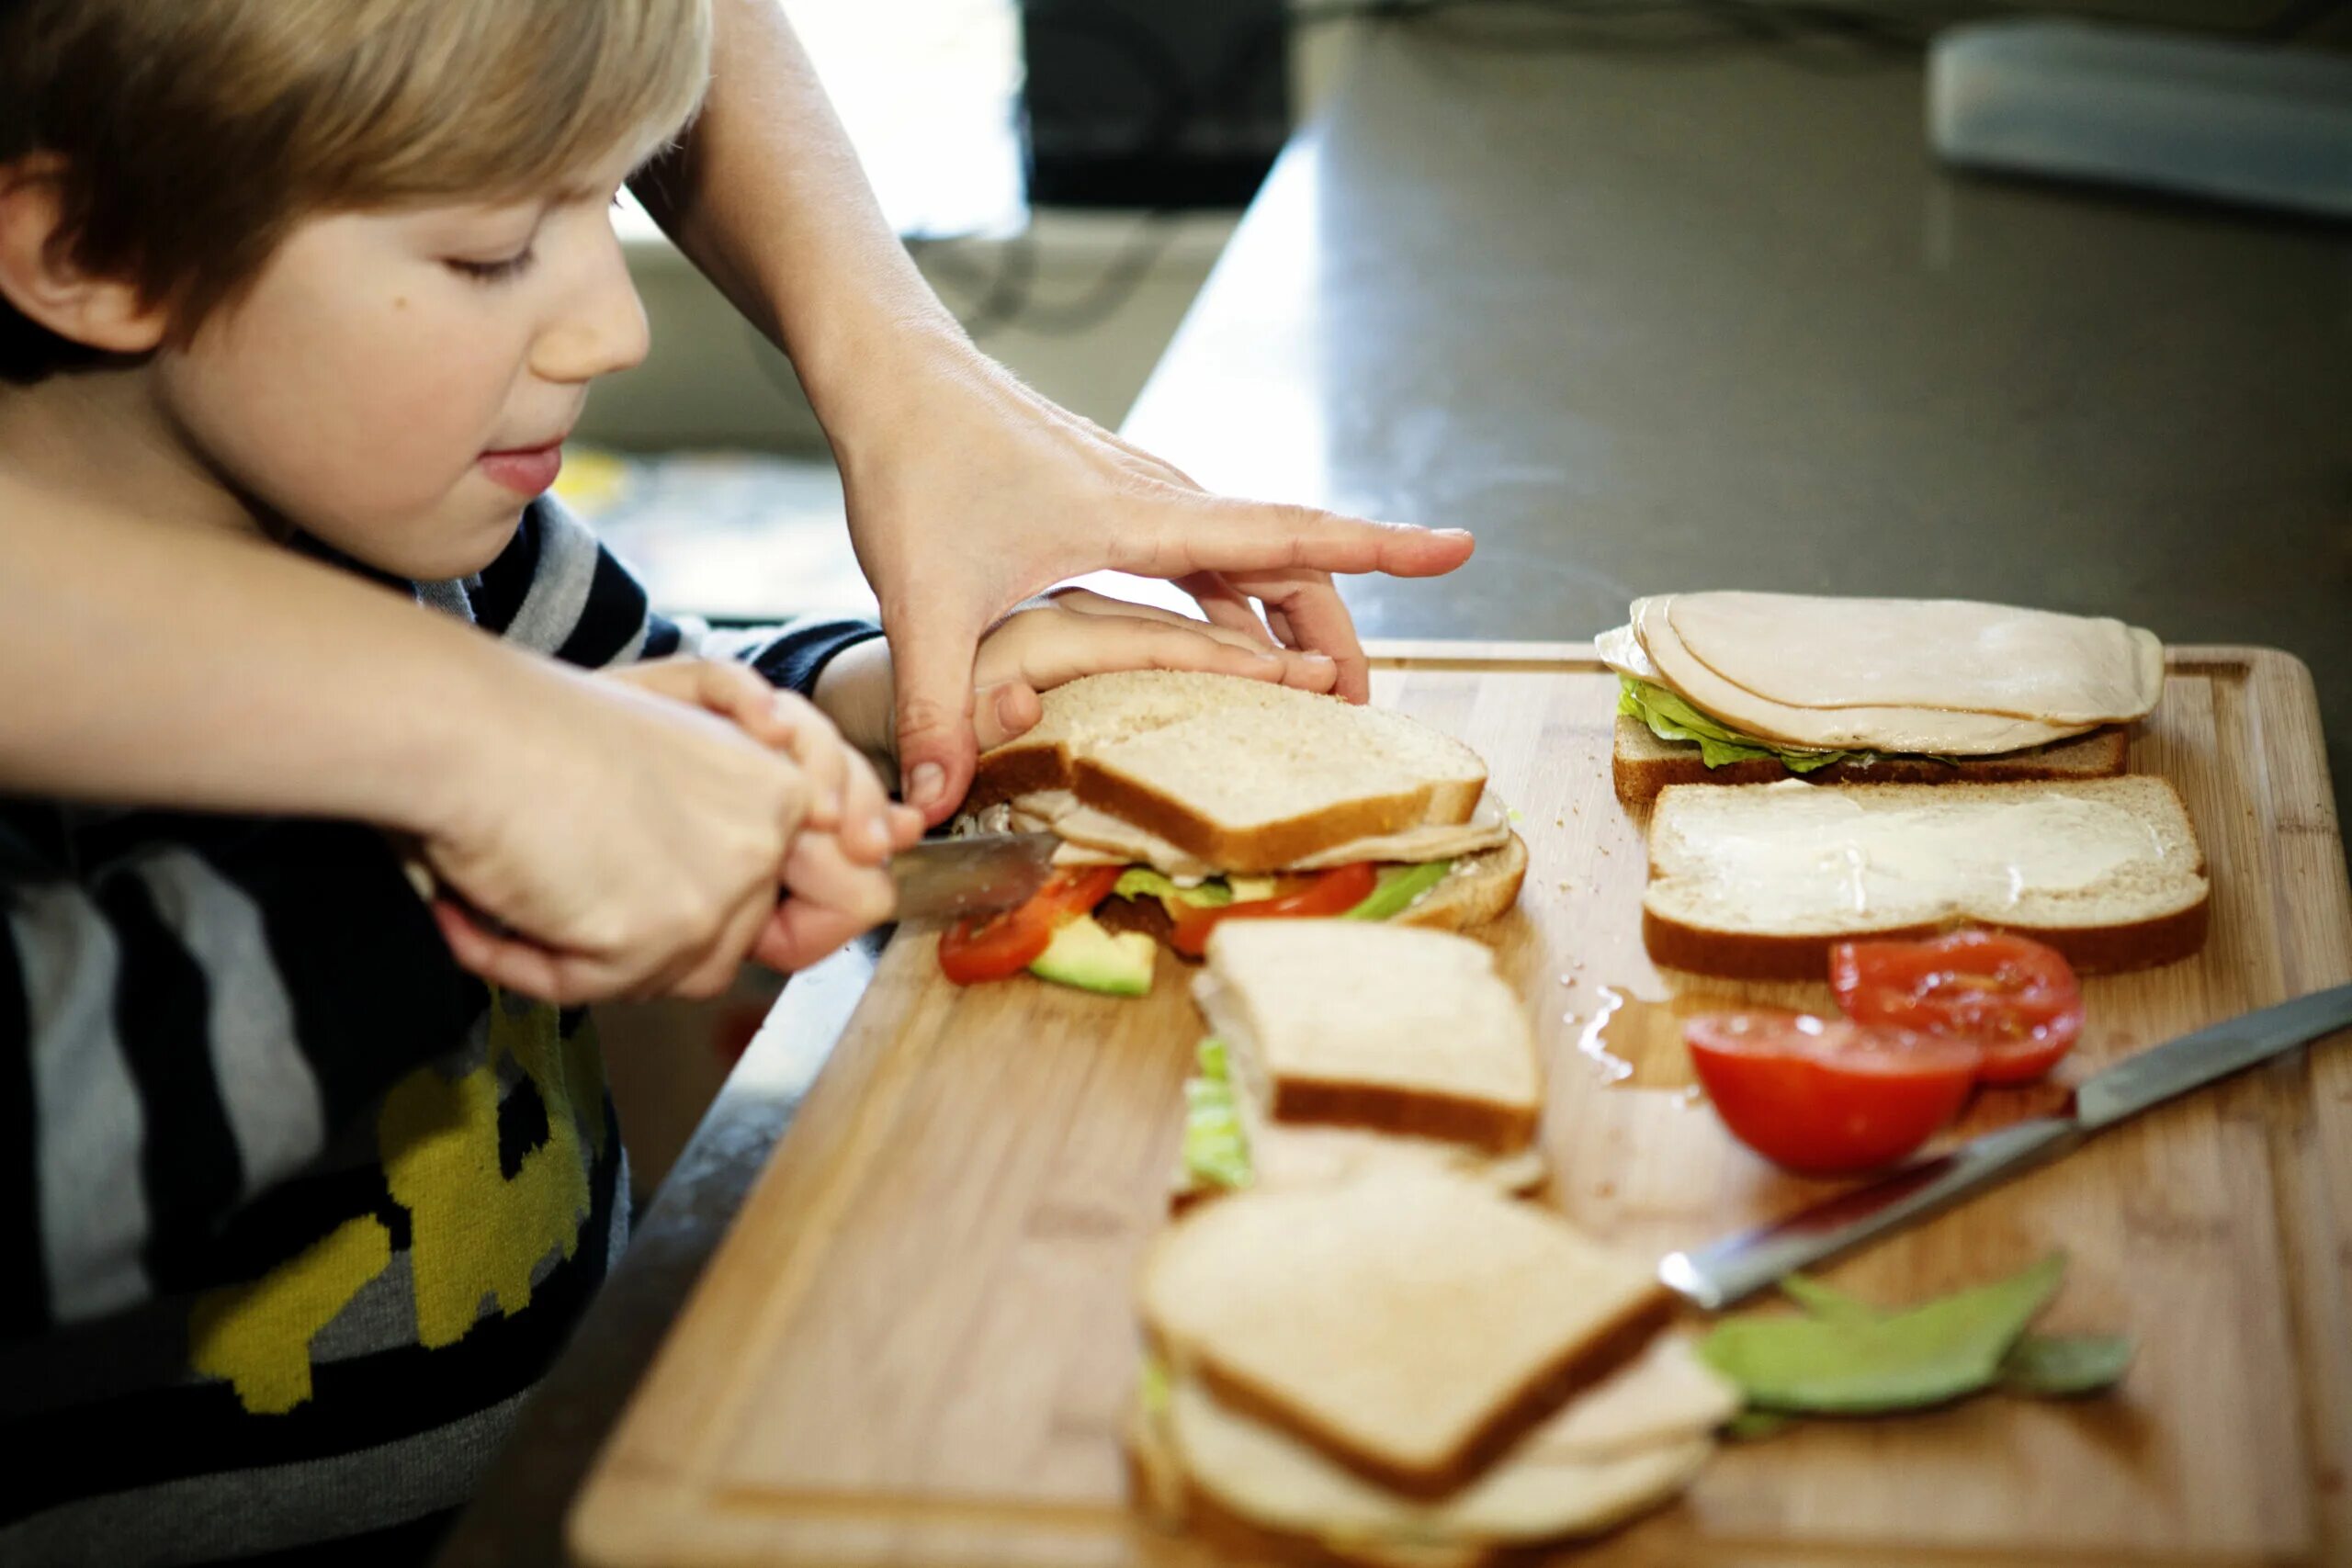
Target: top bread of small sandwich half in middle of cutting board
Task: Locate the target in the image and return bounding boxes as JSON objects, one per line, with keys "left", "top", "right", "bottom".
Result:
{"left": 1193, "top": 919, "right": 1543, "bottom": 1155}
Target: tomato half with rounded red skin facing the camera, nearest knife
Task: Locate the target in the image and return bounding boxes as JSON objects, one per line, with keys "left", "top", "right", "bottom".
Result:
{"left": 1681, "top": 1009, "right": 1983, "bottom": 1176}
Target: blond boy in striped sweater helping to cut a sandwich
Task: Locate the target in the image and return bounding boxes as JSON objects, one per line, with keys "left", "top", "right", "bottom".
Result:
{"left": 0, "top": 0, "right": 1334, "bottom": 1563}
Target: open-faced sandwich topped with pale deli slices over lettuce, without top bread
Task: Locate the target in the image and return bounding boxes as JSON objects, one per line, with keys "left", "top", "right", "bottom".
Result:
{"left": 1597, "top": 592, "right": 2164, "bottom": 804}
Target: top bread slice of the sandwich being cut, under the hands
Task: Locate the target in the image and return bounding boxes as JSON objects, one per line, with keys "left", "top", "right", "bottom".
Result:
{"left": 967, "top": 670, "right": 1487, "bottom": 872}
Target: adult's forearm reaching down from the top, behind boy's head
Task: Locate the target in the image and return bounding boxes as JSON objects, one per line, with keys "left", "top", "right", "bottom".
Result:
{"left": 638, "top": 0, "right": 981, "bottom": 445}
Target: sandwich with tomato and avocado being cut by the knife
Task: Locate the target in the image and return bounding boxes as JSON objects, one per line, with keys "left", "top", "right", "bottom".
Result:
{"left": 941, "top": 670, "right": 1526, "bottom": 995}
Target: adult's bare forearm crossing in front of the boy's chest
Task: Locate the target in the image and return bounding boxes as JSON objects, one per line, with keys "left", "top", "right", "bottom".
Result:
{"left": 0, "top": 514, "right": 513, "bottom": 832}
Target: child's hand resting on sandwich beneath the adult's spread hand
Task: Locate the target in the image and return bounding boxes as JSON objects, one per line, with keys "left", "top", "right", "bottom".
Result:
{"left": 971, "top": 588, "right": 1339, "bottom": 750}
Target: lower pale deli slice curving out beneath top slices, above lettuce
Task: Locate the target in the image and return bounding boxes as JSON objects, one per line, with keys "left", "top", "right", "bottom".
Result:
{"left": 1633, "top": 594, "right": 2098, "bottom": 757}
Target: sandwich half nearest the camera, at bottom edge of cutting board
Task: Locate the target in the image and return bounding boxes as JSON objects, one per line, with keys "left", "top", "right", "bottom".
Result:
{"left": 1129, "top": 1166, "right": 1740, "bottom": 1568}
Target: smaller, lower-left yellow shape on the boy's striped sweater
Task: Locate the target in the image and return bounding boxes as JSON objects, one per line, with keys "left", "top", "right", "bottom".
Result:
{"left": 188, "top": 1213, "right": 393, "bottom": 1416}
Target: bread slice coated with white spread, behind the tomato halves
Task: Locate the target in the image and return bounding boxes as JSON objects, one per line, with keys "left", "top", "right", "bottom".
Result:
{"left": 1642, "top": 776, "right": 2211, "bottom": 980}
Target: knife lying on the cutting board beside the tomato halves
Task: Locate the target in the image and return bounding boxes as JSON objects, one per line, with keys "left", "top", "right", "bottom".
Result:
{"left": 1658, "top": 985, "right": 2352, "bottom": 1312}
